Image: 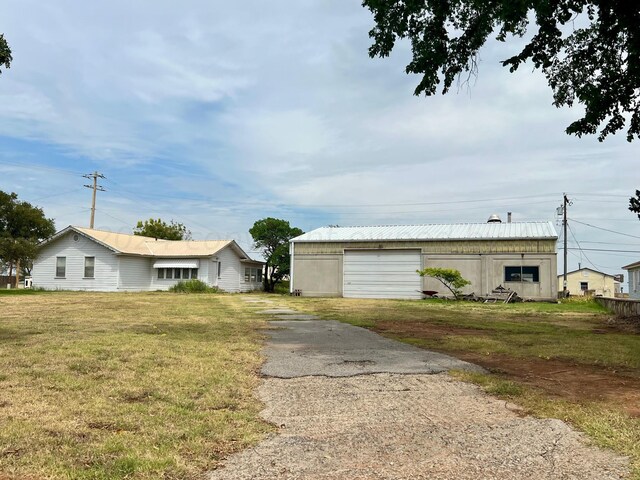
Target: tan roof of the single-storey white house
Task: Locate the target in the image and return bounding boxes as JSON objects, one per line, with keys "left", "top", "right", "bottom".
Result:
{"left": 42, "top": 226, "right": 254, "bottom": 261}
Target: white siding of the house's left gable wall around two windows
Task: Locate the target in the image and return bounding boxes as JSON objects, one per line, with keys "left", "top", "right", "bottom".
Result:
{"left": 31, "top": 231, "right": 119, "bottom": 292}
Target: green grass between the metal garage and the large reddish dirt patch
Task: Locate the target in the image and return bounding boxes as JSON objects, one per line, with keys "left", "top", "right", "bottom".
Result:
{"left": 282, "top": 297, "right": 640, "bottom": 369}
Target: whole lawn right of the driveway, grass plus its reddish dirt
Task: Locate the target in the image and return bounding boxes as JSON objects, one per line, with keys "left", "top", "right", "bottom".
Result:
{"left": 282, "top": 297, "right": 640, "bottom": 480}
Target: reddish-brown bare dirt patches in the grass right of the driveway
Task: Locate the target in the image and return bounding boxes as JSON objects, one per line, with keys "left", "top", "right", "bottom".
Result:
{"left": 375, "top": 322, "right": 640, "bottom": 417}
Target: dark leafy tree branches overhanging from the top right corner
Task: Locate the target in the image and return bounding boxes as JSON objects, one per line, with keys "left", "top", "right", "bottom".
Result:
{"left": 363, "top": 0, "right": 640, "bottom": 141}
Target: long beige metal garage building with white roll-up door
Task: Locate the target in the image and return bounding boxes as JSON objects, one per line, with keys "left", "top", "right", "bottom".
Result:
{"left": 290, "top": 220, "right": 558, "bottom": 300}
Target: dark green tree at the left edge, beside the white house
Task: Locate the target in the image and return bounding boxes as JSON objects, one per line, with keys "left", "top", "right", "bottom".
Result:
{"left": 0, "top": 191, "right": 55, "bottom": 286}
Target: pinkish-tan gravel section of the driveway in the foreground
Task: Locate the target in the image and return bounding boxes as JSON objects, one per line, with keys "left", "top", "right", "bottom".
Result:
{"left": 209, "top": 374, "right": 627, "bottom": 480}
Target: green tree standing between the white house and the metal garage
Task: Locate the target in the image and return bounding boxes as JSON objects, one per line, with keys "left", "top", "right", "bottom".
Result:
{"left": 249, "top": 217, "right": 304, "bottom": 292}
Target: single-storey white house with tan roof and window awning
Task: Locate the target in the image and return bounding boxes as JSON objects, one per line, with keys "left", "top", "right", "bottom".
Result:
{"left": 32, "top": 226, "right": 263, "bottom": 292}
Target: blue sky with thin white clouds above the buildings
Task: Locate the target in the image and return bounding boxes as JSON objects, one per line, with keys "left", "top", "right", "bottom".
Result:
{"left": 0, "top": 0, "right": 640, "bottom": 280}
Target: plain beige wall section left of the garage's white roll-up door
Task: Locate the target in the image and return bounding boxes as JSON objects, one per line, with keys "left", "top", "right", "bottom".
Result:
{"left": 293, "top": 254, "right": 342, "bottom": 297}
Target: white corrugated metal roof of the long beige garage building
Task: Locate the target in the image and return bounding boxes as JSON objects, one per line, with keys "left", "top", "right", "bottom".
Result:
{"left": 292, "top": 222, "right": 558, "bottom": 242}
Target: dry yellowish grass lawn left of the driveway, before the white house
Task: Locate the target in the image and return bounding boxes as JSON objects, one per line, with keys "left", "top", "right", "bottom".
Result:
{"left": 0, "top": 292, "right": 271, "bottom": 480}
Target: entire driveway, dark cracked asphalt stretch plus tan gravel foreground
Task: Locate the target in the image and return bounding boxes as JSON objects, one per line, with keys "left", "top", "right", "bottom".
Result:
{"left": 209, "top": 302, "right": 628, "bottom": 480}
